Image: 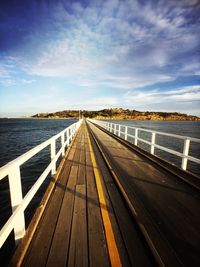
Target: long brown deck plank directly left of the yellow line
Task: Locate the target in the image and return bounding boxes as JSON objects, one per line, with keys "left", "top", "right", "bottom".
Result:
{"left": 86, "top": 151, "right": 110, "bottom": 267}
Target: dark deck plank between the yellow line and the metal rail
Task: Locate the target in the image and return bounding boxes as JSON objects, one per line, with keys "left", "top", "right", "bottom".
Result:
{"left": 92, "top": 140, "right": 155, "bottom": 267}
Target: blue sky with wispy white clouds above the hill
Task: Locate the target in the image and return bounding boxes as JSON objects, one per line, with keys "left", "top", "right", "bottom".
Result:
{"left": 0, "top": 0, "right": 200, "bottom": 116}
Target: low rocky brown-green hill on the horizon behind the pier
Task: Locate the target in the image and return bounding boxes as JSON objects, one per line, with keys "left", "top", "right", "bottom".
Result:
{"left": 32, "top": 108, "right": 200, "bottom": 121}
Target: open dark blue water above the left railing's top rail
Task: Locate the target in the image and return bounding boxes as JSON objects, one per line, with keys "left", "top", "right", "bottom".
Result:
{"left": 0, "top": 119, "right": 76, "bottom": 167}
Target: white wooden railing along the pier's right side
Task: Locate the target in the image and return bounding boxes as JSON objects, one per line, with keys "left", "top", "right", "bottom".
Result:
{"left": 90, "top": 120, "right": 200, "bottom": 174}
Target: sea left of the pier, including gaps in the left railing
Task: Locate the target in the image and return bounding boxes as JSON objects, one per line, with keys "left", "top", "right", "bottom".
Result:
{"left": 0, "top": 119, "right": 77, "bottom": 266}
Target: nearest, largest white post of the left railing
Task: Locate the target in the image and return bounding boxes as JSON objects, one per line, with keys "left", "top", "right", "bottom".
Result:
{"left": 8, "top": 166, "right": 25, "bottom": 244}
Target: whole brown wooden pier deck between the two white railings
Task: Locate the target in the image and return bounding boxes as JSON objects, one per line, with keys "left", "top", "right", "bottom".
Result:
{"left": 5, "top": 122, "right": 200, "bottom": 267}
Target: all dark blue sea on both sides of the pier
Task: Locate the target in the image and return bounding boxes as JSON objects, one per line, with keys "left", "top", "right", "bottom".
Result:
{"left": 0, "top": 118, "right": 200, "bottom": 266}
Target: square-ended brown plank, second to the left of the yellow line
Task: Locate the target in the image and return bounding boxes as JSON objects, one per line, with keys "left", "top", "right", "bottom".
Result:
{"left": 68, "top": 185, "right": 88, "bottom": 267}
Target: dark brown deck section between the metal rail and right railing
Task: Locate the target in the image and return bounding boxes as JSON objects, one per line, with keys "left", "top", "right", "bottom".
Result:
{"left": 89, "top": 122, "right": 200, "bottom": 266}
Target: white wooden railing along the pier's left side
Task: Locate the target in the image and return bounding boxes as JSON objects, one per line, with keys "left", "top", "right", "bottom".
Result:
{"left": 0, "top": 120, "right": 82, "bottom": 248}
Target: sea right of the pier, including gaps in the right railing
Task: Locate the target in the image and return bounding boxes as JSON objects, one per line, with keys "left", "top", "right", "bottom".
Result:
{"left": 106, "top": 120, "right": 200, "bottom": 175}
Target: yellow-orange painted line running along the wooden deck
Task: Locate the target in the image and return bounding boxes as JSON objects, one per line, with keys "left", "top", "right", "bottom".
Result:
{"left": 87, "top": 126, "right": 122, "bottom": 267}
